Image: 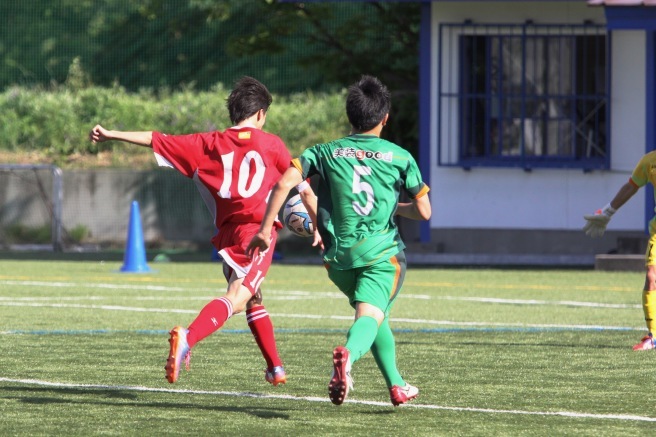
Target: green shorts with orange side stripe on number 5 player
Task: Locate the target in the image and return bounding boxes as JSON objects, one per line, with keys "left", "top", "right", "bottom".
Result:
{"left": 326, "top": 251, "right": 406, "bottom": 317}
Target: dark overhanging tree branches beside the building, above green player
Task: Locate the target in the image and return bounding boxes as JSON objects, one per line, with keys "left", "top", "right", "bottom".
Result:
{"left": 229, "top": 0, "right": 421, "bottom": 151}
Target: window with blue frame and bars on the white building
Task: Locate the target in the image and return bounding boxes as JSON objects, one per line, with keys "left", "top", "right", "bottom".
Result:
{"left": 438, "top": 23, "right": 610, "bottom": 170}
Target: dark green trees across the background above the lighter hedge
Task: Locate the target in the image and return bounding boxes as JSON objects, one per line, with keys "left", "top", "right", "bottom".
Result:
{"left": 0, "top": 0, "right": 420, "bottom": 150}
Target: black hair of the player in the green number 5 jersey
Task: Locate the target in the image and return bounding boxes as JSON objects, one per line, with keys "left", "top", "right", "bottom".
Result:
{"left": 346, "top": 75, "right": 391, "bottom": 132}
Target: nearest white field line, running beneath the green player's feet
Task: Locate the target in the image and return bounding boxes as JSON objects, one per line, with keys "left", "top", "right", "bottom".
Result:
{"left": 0, "top": 378, "right": 656, "bottom": 422}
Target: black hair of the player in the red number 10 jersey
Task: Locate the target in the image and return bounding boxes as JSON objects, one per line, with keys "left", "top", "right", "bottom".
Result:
{"left": 227, "top": 76, "right": 273, "bottom": 124}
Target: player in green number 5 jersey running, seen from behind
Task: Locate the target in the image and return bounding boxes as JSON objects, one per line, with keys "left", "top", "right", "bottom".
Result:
{"left": 247, "top": 76, "right": 431, "bottom": 406}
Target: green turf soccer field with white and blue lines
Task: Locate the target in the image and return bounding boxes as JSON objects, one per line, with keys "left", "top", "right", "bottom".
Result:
{"left": 0, "top": 261, "right": 656, "bottom": 436}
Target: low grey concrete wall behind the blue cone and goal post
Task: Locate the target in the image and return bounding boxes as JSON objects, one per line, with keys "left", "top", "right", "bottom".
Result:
{"left": 0, "top": 169, "right": 214, "bottom": 244}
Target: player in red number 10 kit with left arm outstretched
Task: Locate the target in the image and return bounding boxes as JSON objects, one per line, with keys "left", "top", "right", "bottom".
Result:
{"left": 89, "top": 77, "right": 316, "bottom": 385}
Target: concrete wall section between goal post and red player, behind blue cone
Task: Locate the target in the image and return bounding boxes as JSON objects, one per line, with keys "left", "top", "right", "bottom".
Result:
{"left": 63, "top": 169, "right": 214, "bottom": 245}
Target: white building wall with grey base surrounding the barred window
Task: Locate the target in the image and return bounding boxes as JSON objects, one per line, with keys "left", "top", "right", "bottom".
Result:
{"left": 422, "top": 2, "right": 651, "bottom": 253}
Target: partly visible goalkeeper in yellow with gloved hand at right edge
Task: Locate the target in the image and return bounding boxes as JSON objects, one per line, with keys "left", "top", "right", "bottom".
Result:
{"left": 583, "top": 151, "right": 656, "bottom": 351}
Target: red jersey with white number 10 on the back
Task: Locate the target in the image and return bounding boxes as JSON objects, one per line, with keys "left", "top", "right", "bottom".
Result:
{"left": 152, "top": 127, "right": 291, "bottom": 229}
